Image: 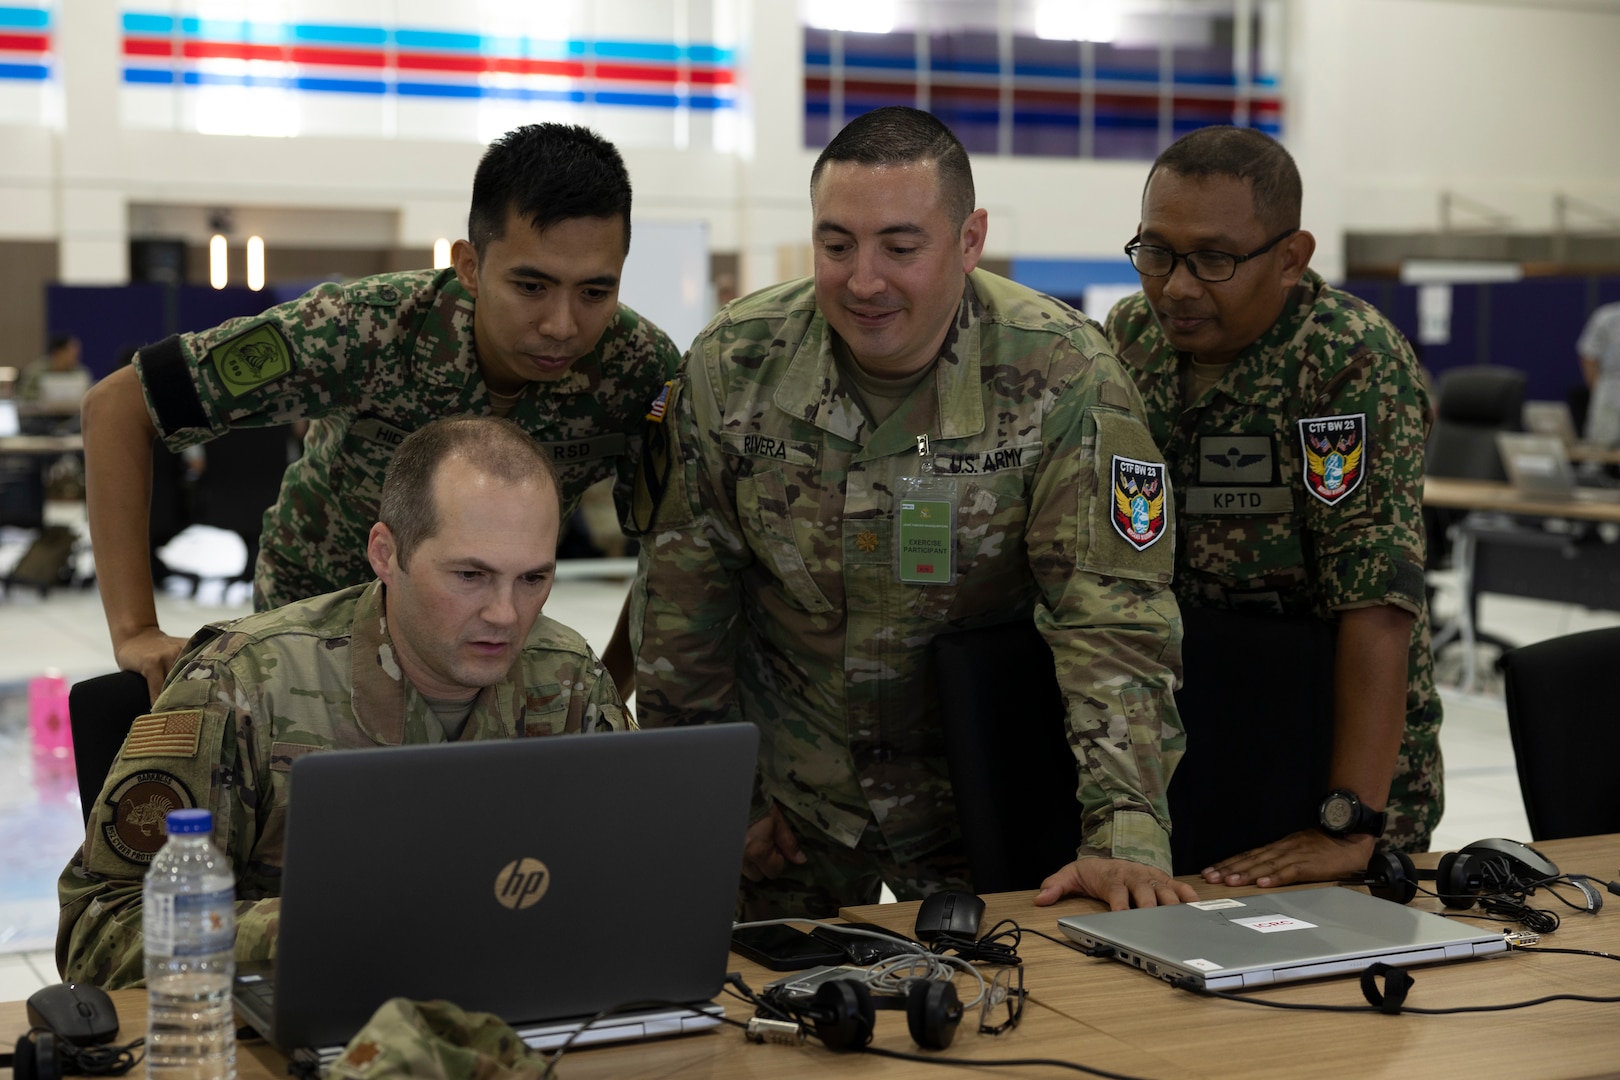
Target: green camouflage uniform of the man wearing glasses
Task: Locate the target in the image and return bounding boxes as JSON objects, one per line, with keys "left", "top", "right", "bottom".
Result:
{"left": 1106, "top": 270, "right": 1443, "bottom": 855}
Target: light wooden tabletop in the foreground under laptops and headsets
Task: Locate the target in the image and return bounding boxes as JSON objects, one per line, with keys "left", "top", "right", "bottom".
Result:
{"left": 0, "top": 834, "right": 1620, "bottom": 1080}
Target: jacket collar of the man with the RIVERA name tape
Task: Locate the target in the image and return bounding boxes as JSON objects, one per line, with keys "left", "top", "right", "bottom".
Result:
{"left": 773, "top": 275, "right": 985, "bottom": 458}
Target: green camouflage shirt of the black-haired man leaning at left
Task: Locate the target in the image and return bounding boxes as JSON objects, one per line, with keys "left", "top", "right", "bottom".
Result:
{"left": 134, "top": 270, "right": 680, "bottom": 610}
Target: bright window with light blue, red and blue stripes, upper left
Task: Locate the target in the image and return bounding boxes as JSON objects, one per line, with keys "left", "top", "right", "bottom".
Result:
{"left": 122, "top": 0, "right": 739, "bottom": 149}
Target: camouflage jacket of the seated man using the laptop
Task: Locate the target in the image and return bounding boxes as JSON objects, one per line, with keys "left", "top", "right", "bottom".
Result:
{"left": 57, "top": 581, "right": 632, "bottom": 988}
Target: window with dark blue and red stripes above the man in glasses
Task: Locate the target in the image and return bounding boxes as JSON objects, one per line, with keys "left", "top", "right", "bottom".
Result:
{"left": 800, "top": 0, "right": 1285, "bottom": 160}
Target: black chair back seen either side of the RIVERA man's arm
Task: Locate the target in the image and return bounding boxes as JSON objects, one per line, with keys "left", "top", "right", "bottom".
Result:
{"left": 932, "top": 609, "right": 1333, "bottom": 892}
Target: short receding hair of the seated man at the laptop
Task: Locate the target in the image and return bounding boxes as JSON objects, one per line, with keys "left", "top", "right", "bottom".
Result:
{"left": 377, "top": 416, "right": 559, "bottom": 570}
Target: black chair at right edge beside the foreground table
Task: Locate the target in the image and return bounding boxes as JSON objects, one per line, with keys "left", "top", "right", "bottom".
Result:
{"left": 1502, "top": 627, "right": 1620, "bottom": 840}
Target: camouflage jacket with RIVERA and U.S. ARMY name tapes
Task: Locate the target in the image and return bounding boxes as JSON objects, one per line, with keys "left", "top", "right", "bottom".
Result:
{"left": 630, "top": 270, "right": 1183, "bottom": 868}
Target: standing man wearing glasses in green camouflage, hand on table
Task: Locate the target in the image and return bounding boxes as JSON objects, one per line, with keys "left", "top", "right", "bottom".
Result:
{"left": 1106, "top": 128, "right": 1442, "bottom": 886}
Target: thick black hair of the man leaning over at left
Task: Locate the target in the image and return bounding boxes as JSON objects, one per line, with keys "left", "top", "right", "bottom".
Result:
{"left": 467, "top": 123, "right": 630, "bottom": 256}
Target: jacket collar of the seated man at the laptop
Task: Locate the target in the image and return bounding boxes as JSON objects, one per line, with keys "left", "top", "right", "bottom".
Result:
{"left": 348, "top": 581, "right": 523, "bottom": 746}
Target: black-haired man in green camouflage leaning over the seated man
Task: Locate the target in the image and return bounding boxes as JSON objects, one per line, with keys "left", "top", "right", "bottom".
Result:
{"left": 84, "top": 123, "right": 679, "bottom": 705}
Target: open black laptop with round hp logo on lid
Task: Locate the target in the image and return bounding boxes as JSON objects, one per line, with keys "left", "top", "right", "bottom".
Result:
{"left": 235, "top": 724, "right": 758, "bottom": 1064}
